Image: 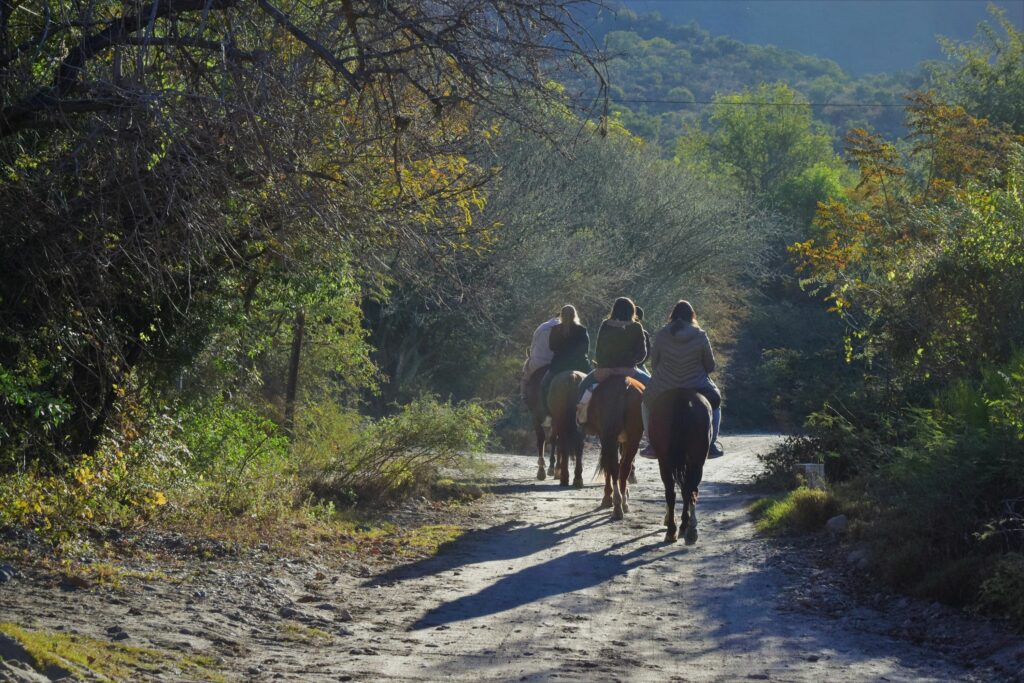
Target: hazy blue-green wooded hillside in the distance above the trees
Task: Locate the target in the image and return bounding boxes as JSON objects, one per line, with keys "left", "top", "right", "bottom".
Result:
{"left": 573, "top": 7, "right": 924, "bottom": 156}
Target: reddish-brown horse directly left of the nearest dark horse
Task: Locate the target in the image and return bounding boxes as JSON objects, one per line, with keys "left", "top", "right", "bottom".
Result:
{"left": 586, "top": 375, "right": 643, "bottom": 519}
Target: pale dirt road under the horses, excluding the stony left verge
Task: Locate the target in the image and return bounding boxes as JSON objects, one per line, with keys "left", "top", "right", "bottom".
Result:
{"left": 346, "top": 436, "right": 991, "bottom": 682}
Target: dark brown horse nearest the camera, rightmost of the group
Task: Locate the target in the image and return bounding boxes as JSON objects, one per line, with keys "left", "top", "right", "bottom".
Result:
{"left": 649, "top": 389, "right": 712, "bottom": 546}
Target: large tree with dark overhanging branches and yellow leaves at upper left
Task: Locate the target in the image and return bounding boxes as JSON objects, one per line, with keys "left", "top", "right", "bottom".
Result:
{"left": 0, "top": 0, "right": 593, "bottom": 463}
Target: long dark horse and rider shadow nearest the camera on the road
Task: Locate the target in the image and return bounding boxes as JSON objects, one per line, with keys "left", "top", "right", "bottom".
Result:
{"left": 410, "top": 532, "right": 689, "bottom": 631}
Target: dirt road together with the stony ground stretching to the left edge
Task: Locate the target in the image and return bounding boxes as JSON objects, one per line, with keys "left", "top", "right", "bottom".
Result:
{"left": 0, "top": 436, "right": 1007, "bottom": 683}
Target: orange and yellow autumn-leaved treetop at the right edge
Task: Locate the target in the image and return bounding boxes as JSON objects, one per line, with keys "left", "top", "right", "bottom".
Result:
{"left": 792, "top": 95, "right": 1024, "bottom": 387}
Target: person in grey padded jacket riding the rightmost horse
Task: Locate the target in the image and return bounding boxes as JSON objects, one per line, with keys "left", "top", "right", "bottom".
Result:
{"left": 643, "top": 301, "right": 724, "bottom": 456}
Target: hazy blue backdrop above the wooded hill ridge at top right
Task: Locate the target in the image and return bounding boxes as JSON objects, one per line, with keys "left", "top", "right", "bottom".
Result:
{"left": 623, "top": 0, "right": 1024, "bottom": 76}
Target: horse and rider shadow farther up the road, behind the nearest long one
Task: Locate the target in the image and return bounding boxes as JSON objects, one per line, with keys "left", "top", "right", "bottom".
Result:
{"left": 364, "top": 510, "right": 610, "bottom": 587}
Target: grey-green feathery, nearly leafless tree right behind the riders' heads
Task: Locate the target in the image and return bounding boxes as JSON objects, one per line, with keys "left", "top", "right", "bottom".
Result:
{"left": 367, "top": 115, "right": 771, "bottom": 411}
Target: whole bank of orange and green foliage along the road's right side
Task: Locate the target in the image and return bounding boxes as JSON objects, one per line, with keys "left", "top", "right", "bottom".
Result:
{"left": 769, "top": 61, "right": 1024, "bottom": 618}
